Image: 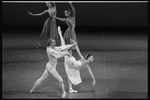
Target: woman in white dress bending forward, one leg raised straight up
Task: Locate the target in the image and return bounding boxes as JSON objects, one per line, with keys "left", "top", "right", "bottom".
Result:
{"left": 58, "top": 27, "right": 95, "bottom": 93}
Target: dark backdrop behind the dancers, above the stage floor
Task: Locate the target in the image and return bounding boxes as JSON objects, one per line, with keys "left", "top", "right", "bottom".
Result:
{"left": 2, "top": 2, "right": 148, "bottom": 31}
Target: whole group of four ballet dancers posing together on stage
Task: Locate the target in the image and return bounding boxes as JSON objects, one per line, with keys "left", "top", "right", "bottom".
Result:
{"left": 29, "top": 2, "right": 95, "bottom": 98}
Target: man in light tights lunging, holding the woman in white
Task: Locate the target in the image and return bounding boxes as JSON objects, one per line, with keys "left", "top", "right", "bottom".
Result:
{"left": 30, "top": 27, "right": 76, "bottom": 97}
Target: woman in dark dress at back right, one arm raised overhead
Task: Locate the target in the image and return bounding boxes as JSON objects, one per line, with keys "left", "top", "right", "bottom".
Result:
{"left": 52, "top": 2, "right": 77, "bottom": 54}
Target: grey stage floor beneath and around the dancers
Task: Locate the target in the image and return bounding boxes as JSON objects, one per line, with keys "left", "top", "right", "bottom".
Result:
{"left": 2, "top": 32, "right": 148, "bottom": 99}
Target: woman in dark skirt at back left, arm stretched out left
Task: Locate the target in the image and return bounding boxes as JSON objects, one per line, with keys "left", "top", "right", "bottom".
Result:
{"left": 28, "top": 2, "right": 58, "bottom": 48}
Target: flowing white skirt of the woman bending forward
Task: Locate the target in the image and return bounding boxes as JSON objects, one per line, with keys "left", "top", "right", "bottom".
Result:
{"left": 64, "top": 56, "right": 82, "bottom": 85}
